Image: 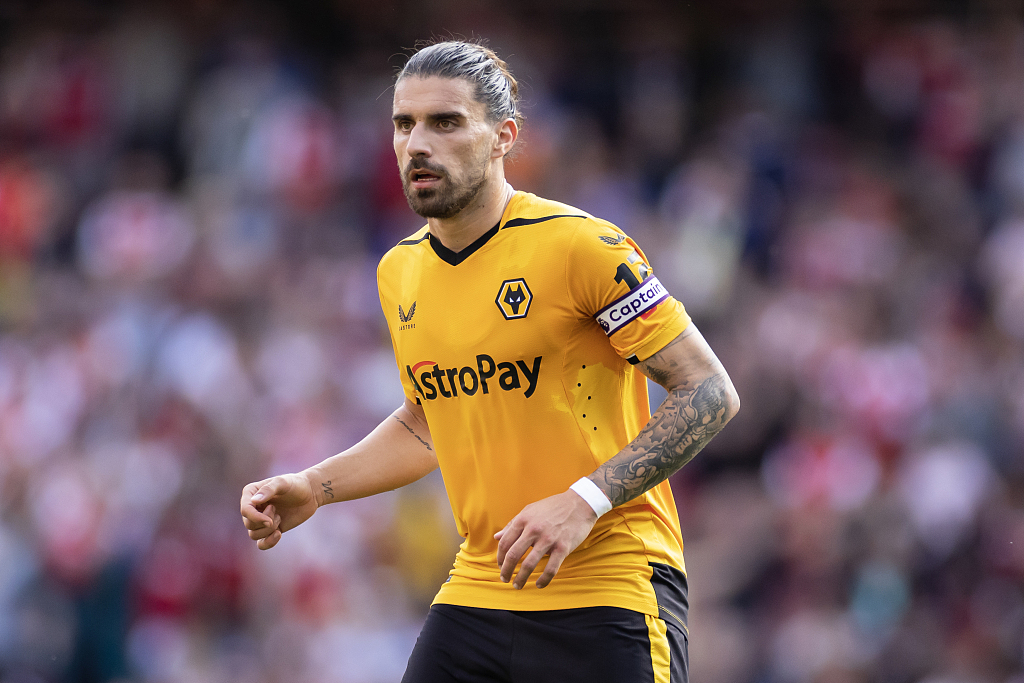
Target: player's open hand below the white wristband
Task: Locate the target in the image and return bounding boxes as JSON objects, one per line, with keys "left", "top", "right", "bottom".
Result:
{"left": 495, "top": 490, "right": 597, "bottom": 589}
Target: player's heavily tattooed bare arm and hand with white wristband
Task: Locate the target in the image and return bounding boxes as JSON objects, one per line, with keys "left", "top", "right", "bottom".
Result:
{"left": 495, "top": 324, "right": 739, "bottom": 588}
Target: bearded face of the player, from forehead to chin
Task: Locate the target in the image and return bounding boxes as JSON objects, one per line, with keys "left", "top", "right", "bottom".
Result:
{"left": 392, "top": 76, "right": 495, "bottom": 218}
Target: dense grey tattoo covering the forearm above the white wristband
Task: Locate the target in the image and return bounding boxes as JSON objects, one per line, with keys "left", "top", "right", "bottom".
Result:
{"left": 591, "top": 369, "right": 730, "bottom": 506}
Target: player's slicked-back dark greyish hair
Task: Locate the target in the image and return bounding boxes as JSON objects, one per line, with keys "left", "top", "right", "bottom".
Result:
{"left": 395, "top": 40, "right": 525, "bottom": 128}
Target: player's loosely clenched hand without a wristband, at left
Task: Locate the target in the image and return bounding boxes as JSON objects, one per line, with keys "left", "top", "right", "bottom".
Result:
{"left": 242, "top": 474, "right": 318, "bottom": 550}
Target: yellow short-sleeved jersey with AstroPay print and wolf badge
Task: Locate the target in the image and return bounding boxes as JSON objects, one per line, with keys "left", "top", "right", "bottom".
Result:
{"left": 377, "top": 193, "right": 690, "bottom": 616}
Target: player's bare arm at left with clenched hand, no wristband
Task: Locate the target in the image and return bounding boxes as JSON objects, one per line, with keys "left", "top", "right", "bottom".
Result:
{"left": 242, "top": 398, "right": 437, "bottom": 550}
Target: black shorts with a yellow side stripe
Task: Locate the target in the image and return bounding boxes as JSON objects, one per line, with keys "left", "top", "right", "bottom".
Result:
{"left": 402, "top": 564, "right": 689, "bottom": 683}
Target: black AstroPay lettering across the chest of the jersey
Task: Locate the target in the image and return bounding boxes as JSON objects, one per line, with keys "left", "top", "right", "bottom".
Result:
{"left": 406, "top": 353, "right": 542, "bottom": 400}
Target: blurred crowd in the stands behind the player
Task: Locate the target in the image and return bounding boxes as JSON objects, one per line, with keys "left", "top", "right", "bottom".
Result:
{"left": 0, "top": 0, "right": 1024, "bottom": 683}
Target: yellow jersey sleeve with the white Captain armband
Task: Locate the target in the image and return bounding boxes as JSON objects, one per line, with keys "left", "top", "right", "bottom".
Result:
{"left": 566, "top": 218, "right": 690, "bottom": 364}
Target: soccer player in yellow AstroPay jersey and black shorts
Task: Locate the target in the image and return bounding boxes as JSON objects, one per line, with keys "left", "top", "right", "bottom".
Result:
{"left": 242, "top": 41, "right": 739, "bottom": 683}
